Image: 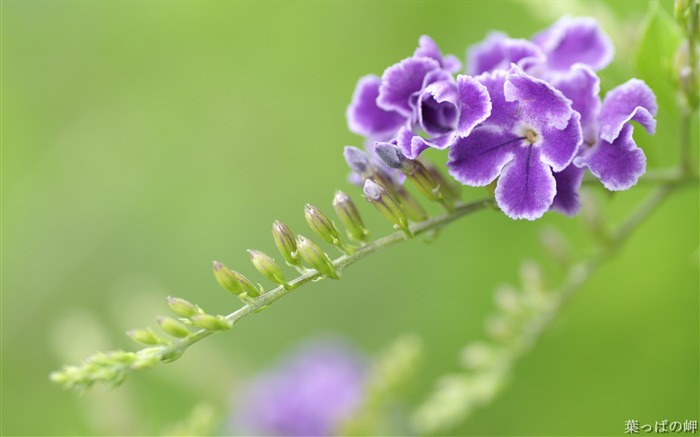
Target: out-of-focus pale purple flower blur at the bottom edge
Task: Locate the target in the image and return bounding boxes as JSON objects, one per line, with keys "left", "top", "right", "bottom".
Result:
{"left": 232, "top": 341, "right": 365, "bottom": 437}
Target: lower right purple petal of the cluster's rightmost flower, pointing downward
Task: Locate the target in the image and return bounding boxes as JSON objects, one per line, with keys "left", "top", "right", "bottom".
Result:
{"left": 574, "top": 124, "right": 647, "bottom": 191}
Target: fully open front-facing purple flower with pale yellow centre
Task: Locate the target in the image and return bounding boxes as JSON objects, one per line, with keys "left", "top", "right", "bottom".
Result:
{"left": 447, "top": 65, "right": 582, "bottom": 220}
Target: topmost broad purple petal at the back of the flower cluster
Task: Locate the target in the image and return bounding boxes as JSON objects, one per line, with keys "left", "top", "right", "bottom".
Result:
{"left": 532, "top": 17, "right": 614, "bottom": 71}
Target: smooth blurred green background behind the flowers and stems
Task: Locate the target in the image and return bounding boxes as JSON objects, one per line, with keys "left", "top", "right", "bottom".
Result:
{"left": 2, "top": 1, "right": 700, "bottom": 435}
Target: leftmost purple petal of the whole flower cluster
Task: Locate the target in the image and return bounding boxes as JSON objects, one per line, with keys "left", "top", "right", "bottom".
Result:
{"left": 346, "top": 74, "right": 406, "bottom": 138}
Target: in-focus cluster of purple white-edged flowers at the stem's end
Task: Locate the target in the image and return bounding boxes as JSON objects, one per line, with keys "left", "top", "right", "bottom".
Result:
{"left": 347, "top": 18, "right": 658, "bottom": 220}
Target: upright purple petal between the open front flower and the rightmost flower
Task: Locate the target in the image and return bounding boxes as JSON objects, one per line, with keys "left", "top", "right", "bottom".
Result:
{"left": 550, "top": 64, "right": 600, "bottom": 143}
